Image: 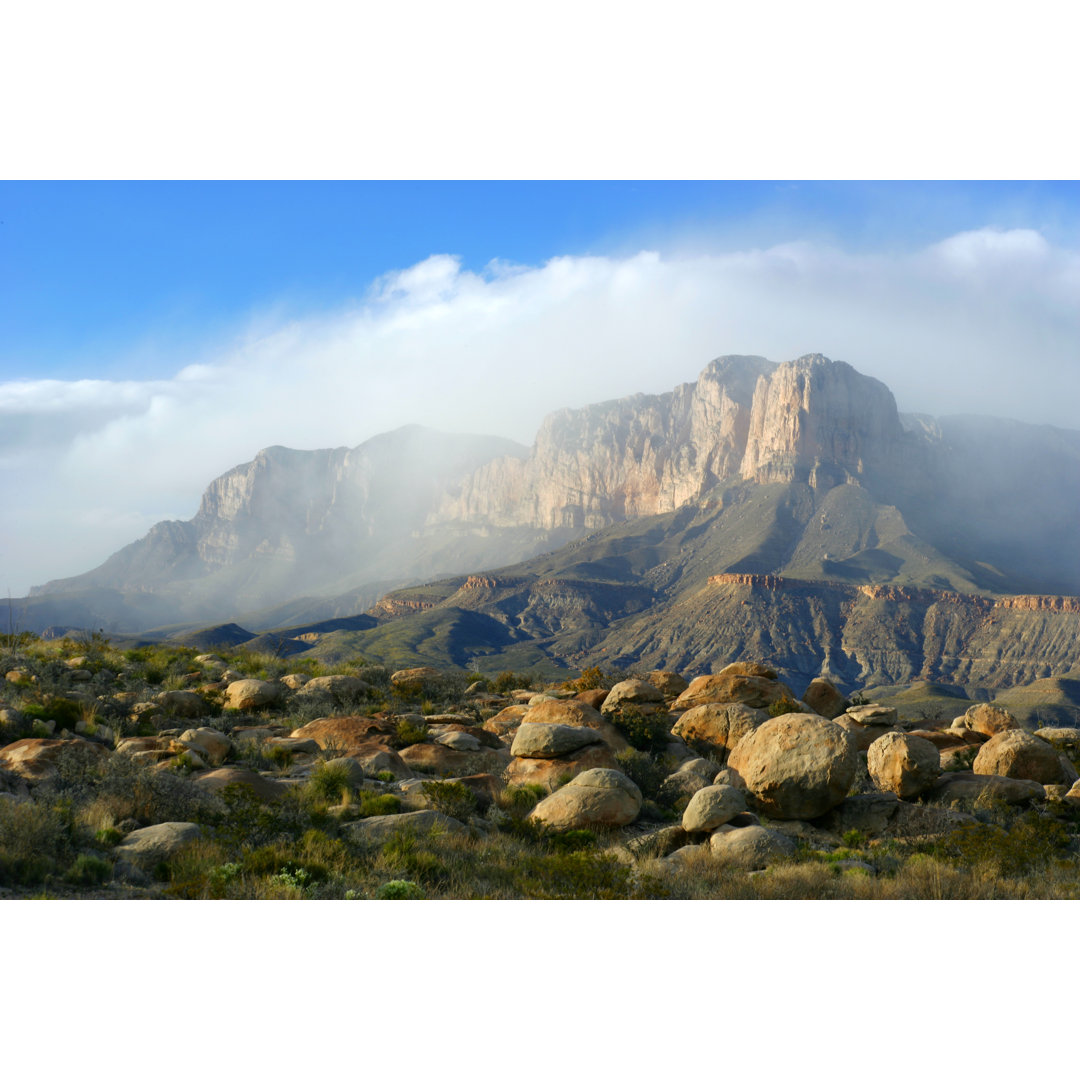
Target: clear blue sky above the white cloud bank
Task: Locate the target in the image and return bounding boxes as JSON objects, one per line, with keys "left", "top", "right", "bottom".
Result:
{"left": 0, "top": 181, "right": 1080, "bottom": 378}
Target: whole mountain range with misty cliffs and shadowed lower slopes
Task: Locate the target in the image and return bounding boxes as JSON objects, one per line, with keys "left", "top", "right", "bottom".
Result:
{"left": 21, "top": 354, "right": 1080, "bottom": 685}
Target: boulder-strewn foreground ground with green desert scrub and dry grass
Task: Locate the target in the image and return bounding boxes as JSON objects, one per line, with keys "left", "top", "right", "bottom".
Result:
{"left": 0, "top": 635, "right": 1080, "bottom": 899}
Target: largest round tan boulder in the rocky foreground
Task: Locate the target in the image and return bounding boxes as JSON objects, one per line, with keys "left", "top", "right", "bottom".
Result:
{"left": 728, "top": 713, "right": 859, "bottom": 821}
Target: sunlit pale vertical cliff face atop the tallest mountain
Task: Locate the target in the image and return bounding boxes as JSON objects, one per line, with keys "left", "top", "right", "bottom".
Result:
{"left": 431, "top": 355, "right": 916, "bottom": 531}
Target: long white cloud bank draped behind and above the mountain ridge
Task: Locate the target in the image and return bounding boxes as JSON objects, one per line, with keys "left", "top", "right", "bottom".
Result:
{"left": 0, "top": 228, "right": 1080, "bottom": 594}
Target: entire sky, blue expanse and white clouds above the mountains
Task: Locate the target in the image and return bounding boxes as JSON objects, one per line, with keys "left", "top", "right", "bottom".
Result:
{"left": 0, "top": 180, "right": 1080, "bottom": 596}
